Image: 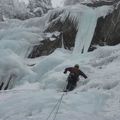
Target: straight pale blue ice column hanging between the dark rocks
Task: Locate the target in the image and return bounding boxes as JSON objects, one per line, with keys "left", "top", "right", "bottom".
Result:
{"left": 73, "top": 8, "right": 97, "bottom": 54}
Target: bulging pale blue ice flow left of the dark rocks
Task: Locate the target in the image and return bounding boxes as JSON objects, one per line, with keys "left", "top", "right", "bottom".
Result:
{"left": 0, "top": 16, "right": 46, "bottom": 89}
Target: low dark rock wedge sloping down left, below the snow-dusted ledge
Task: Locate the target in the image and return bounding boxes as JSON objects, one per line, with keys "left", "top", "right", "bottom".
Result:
{"left": 28, "top": 34, "right": 62, "bottom": 58}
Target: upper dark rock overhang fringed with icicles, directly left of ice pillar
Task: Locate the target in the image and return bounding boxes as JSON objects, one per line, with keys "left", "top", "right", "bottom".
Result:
{"left": 45, "top": 11, "right": 77, "bottom": 50}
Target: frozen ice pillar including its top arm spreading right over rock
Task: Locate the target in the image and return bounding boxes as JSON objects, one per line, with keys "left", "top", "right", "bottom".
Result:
{"left": 73, "top": 6, "right": 113, "bottom": 54}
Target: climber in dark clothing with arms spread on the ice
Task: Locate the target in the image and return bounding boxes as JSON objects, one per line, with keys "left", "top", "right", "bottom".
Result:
{"left": 64, "top": 64, "right": 87, "bottom": 92}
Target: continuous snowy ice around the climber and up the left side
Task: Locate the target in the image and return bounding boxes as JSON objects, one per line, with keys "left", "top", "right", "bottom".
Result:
{"left": 0, "top": 3, "right": 120, "bottom": 120}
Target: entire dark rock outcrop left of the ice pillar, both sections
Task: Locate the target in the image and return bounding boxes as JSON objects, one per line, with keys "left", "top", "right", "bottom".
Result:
{"left": 28, "top": 11, "right": 77, "bottom": 58}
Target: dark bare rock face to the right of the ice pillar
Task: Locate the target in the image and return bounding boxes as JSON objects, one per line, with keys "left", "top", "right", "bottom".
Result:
{"left": 92, "top": 2, "right": 120, "bottom": 45}
